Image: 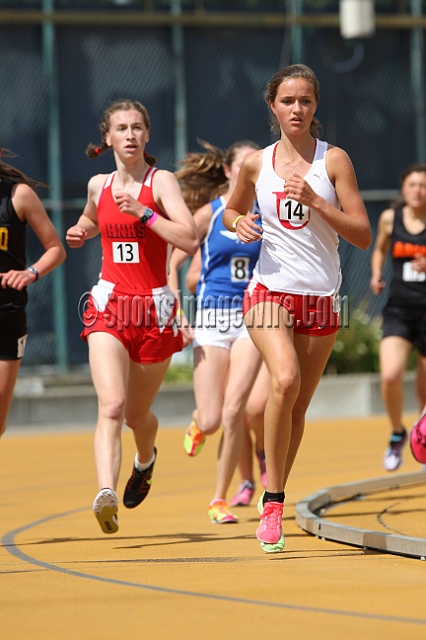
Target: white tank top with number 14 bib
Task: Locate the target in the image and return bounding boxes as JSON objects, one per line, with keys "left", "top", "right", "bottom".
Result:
{"left": 249, "top": 140, "right": 341, "bottom": 296}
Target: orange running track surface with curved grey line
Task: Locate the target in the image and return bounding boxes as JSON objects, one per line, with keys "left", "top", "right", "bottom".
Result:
{"left": 0, "top": 416, "right": 426, "bottom": 640}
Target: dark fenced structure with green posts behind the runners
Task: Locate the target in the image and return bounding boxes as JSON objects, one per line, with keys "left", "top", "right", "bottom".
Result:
{"left": 0, "top": 0, "right": 426, "bottom": 369}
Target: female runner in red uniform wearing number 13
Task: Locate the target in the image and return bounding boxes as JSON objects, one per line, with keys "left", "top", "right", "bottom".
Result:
{"left": 66, "top": 101, "right": 199, "bottom": 533}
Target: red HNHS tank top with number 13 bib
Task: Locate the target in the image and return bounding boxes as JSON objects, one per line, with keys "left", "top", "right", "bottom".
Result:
{"left": 98, "top": 167, "right": 171, "bottom": 293}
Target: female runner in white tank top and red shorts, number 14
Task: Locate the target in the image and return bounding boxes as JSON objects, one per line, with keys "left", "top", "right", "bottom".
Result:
{"left": 223, "top": 64, "right": 371, "bottom": 553}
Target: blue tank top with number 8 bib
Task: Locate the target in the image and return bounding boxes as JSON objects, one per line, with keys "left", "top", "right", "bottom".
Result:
{"left": 197, "top": 197, "right": 260, "bottom": 309}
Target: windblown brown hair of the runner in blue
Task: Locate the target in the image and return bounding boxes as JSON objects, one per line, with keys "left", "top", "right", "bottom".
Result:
{"left": 175, "top": 140, "right": 259, "bottom": 213}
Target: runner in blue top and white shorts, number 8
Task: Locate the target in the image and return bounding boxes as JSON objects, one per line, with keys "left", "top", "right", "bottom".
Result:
{"left": 171, "top": 141, "right": 261, "bottom": 524}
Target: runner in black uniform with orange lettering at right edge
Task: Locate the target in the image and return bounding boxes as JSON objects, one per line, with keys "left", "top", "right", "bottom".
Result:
{"left": 370, "top": 164, "right": 426, "bottom": 471}
